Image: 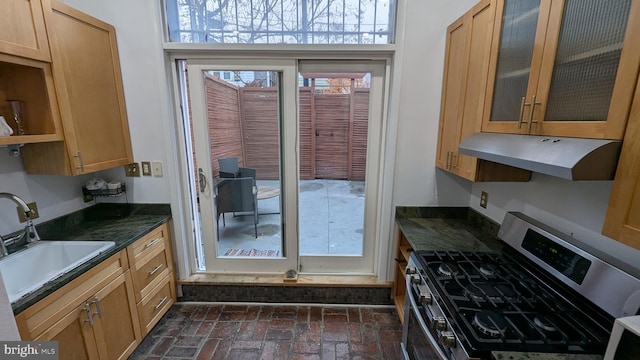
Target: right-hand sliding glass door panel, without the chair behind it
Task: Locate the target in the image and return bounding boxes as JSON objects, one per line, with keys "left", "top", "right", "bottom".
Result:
{"left": 298, "top": 61, "right": 385, "bottom": 274}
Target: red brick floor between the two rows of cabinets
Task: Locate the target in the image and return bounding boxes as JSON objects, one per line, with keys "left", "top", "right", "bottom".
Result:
{"left": 129, "top": 304, "right": 402, "bottom": 360}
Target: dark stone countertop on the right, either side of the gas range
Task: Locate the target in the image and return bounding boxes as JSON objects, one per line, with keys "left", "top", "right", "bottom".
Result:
{"left": 396, "top": 206, "right": 602, "bottom": 360}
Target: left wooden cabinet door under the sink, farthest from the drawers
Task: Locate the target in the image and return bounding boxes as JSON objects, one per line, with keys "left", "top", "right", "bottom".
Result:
{"left": 34, "top": 304, "right": 99, "bottom": 360}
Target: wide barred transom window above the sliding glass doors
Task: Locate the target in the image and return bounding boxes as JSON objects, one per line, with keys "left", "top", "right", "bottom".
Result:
{"left": 165, "top": 0, "right": 395, "bottom": 44}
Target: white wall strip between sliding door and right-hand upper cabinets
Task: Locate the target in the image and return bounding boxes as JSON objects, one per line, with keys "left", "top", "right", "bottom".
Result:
{"left": 393, "top": 0, "right": 477, "bottom": 206}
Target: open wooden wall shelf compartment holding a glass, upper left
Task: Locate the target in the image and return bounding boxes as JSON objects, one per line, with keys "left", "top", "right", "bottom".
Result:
{"left": 0, "top": 53, "right": 63, "bottom": 146}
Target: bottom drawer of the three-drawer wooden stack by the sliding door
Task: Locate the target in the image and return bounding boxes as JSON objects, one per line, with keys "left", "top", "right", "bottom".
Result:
{"left": 138, "top": 276, "right": 176, "bottom": 336}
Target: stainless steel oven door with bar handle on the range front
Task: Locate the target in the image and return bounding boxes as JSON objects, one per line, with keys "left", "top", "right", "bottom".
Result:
{"left": 401, "top": 276, "right": 451, "bottom": 360}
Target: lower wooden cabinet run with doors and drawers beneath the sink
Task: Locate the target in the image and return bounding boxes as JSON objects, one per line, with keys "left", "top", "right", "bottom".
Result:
{"left": 16, "top": 224, "right": 176, "bottom": 360}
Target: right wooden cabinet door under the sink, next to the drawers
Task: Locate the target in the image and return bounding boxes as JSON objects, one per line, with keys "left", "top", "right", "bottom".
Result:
{"left": 88, "top": 270, "right": 142, "bottom": 360}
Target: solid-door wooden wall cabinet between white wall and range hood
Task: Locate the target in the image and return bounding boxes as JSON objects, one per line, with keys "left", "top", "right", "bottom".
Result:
{"left": 436, "top": 0, "right": 531, "bottom": 181}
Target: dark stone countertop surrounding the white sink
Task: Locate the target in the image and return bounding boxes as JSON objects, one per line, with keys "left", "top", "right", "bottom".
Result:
{"left": 9, "top": 203, "right": 171, "bottom": 315}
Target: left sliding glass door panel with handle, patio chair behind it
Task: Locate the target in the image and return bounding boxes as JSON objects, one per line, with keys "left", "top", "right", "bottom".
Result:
{"left": 187, "top": 62, "right": 297, "bottom": 272}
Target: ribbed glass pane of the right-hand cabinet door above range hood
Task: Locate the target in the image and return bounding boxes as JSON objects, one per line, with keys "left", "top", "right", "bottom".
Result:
{"left": 544, "top": 0, "right": 631, "bottom": 121}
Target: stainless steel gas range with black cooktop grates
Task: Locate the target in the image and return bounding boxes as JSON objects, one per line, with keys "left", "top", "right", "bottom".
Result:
{"left": 402, "top": 213, "right": 640, "bottom": 360}
